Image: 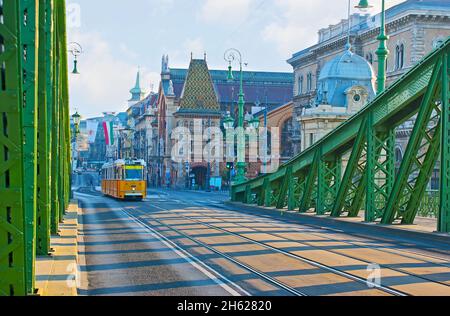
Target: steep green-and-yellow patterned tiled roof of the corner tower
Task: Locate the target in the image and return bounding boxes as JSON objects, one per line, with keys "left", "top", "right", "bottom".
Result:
{"left": 178, "top": 59, "right": 220, "bottom": 113}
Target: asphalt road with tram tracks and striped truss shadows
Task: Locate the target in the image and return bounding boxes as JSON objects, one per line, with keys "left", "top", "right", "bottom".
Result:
{"left": 74, "top": 175, "right": 450, "bottom": 296}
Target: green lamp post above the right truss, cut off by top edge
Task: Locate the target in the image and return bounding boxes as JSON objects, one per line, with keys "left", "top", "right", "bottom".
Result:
{"left": 355, "top": 0, "right": 389, "bottom": 94}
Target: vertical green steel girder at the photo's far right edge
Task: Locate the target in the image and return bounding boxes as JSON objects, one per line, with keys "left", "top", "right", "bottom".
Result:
{"left": 438, "top": 51, "right": 450, "bottom": 233}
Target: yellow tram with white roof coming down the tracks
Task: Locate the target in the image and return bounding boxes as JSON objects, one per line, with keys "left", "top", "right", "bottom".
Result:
{"left": 102, "top": 160, "right": 147, "bottom": 200}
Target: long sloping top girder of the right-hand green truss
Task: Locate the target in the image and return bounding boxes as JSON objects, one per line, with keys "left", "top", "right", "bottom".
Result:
{"left": 233, "top": 39, "right": 450, "bottom": 198}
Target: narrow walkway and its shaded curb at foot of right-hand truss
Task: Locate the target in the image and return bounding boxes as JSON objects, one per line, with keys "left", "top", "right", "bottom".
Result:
{"left": 225, "top": 202, "right": 450, "bottom": 244}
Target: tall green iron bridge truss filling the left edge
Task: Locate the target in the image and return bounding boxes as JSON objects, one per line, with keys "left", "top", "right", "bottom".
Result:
{"left": 0, "top": 0, "right": 70, "bottom": 296}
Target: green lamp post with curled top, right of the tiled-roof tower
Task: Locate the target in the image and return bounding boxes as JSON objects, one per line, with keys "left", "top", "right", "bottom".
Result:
{"left": 224, "top": 48, "right": 247, "bottom": 184}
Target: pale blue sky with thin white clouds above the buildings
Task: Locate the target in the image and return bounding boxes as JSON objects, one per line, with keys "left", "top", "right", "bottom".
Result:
{"left": 67, "top": 0, "right": 404, "bottom": 118}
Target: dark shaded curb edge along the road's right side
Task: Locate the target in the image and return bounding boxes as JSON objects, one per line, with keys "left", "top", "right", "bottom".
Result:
{"left": 224, "top": 201, "right": 450, "bottom": 246}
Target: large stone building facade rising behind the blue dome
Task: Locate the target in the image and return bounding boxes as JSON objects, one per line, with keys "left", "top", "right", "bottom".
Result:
{"left": 288, "top": 0, "right": 450, "bottom": 152}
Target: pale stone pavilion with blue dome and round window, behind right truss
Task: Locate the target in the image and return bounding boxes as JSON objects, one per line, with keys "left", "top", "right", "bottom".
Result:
{"left": 299, "top": 46, "right": 376, "bottom": 150}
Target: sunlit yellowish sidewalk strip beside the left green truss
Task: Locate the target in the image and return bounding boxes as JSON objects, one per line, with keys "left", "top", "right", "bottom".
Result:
{"left": 36, "top": 201, "right": 79, "bottom": 296}
